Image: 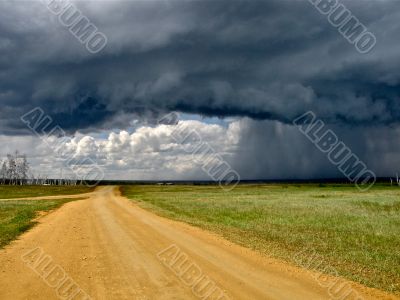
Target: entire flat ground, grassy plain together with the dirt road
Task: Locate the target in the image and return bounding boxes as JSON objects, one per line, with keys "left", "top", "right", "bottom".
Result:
{"left": 0, "top": 184, "right": 400, "bottom": 300}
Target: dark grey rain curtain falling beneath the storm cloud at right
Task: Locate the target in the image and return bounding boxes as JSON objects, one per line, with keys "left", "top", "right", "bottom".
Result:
{"left": 229, "top": 119, "right": 400, "bottom": 179}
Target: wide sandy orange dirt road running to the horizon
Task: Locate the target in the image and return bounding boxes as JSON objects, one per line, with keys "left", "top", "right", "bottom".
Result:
{"left": 0, "top": 186, "right": 392, "bottom": 300}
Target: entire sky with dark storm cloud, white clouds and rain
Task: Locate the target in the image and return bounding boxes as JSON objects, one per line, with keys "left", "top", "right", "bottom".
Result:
{"left": 0, "top": 0, "right": 400, "bottom": 180}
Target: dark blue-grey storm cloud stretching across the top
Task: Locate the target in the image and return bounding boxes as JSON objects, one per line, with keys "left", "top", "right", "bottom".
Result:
{"left": 0, "top": 0, "right": 400, "bottom": 134}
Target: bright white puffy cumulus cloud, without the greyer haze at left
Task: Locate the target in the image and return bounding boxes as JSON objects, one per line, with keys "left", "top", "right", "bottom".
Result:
{"left": 65, "top": 120, "right": 240, "bottom": 179}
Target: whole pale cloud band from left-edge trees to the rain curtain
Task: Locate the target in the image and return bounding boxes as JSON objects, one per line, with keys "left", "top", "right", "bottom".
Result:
{"left": 0, "top": 120, "right": 240, "bottom": 180}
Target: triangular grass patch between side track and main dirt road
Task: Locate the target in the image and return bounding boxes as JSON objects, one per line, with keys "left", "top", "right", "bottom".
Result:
{"left": 0, "top": 198, "right": 83, "bottom": 248}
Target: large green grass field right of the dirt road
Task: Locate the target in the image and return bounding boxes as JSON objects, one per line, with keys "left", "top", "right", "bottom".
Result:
{"left": 121, "top": 184, "right": 400, "bottom": 294}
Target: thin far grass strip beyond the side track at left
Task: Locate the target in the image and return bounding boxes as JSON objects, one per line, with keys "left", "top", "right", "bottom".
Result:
{"left": 0, "top": 185, "right": 93, "bottom": 199}
